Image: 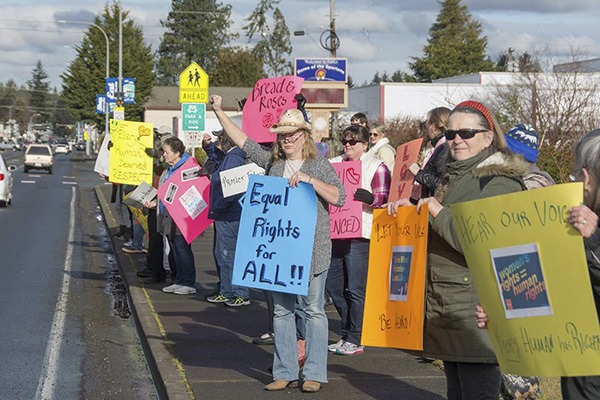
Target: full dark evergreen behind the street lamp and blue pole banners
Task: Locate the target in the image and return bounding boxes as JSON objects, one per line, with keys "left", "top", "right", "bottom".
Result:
{"left": 61, "top": 3, "right": 156, "bottom": 126}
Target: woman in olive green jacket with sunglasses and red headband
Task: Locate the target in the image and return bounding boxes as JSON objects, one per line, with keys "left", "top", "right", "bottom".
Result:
{"left": 388, "top": 100, "right": 528, "bottom": 400}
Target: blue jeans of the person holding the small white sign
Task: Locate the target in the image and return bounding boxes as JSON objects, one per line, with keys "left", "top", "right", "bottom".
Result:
{"left": 214, "top": 221, "right": 250, "bottom": 299}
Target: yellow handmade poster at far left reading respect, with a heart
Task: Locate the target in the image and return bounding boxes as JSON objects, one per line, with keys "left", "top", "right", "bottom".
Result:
{"left": 109, "top": 119, "right": 154, "bottom": 185}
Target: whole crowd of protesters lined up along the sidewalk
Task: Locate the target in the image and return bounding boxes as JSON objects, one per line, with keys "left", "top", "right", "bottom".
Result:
{"left": 113, "top": 95, "right": 600, "bottom": 400}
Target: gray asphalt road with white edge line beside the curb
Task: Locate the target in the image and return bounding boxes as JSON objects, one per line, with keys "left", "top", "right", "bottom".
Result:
{"left": 0, "top": 151, "right": 157, "bottom": 399}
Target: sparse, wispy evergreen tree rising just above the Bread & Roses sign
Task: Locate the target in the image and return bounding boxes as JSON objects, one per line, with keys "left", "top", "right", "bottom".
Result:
{"left": 244, "top": 0, "right": 293, "bottom": 76}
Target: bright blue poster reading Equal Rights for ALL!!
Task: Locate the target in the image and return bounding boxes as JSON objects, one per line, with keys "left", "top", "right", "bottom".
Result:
{"left": 232, "top": 175, "right": 317, "bottom": 295}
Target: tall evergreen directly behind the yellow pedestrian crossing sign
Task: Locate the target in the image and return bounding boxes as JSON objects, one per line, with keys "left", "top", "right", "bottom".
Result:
{"left": 156, "top": 0, "right": 236, "bottom": 86}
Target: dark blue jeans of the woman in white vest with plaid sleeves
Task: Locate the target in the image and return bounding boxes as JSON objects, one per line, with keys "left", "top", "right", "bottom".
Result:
{"left": 327, "top": 239, "right": 370, "bottom": 345}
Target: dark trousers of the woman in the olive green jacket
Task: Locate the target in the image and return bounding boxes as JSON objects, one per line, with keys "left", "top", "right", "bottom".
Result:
{"left": 444, "top": 361, "right": 502, "bottom": 400}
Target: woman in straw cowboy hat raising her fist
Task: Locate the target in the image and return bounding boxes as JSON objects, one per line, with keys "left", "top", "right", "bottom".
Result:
{"left": 210, "top": 95, "right": 345, "bottom": 392}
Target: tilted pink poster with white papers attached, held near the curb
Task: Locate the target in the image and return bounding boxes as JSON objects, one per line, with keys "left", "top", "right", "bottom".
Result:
{"left": 158, "top": 158, "right": 212, "bottom": 243}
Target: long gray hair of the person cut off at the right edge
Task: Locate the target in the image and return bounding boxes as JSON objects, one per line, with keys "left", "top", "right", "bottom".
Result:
{"left": 573, "top": 129, "right": 600, "bottom": 214}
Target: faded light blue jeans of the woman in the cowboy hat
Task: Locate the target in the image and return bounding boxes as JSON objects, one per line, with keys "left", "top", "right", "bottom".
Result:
{"left": 273, "top": 272, "right": 328, "bottom": 383}
